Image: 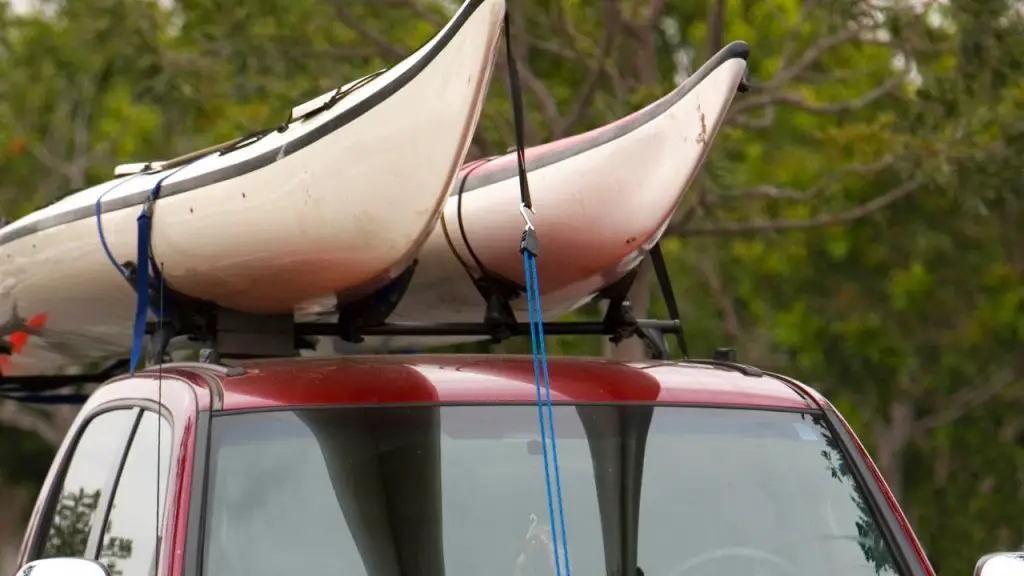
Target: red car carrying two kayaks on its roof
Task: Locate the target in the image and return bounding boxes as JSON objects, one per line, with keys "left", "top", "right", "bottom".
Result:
{"left": 9, "top": 356, "right": 1024, "bottom": 576}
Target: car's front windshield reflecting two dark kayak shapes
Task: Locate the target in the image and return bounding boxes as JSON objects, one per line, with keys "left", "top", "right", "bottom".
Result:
{"left": 205, "top": 405, "right": 897, "bottom": 576}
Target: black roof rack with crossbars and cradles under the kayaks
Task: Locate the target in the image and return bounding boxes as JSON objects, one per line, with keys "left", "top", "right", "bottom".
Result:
{"left": 0, "top": 239, "right": 688, "bottom": 403}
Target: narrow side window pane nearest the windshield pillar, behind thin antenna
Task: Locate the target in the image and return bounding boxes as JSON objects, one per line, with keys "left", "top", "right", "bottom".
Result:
{"left": 98, "top": 411, "right": 172, "bottom": 576}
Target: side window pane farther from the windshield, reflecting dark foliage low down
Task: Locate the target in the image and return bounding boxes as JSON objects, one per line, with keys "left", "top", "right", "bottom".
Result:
{"left": 40, "top": 408, "right": 136, "bottom": 558}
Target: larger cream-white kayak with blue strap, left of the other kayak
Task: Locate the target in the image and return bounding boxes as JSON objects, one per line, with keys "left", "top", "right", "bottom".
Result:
{"left": 0, "top": 0, "right": 505, "bottom": 375}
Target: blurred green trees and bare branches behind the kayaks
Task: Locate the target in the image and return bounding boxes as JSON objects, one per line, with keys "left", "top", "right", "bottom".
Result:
{"left": 0, "top": 0, "right": 1024, "bottom": 574}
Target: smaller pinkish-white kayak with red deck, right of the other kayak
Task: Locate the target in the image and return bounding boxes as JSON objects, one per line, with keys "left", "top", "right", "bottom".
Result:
{"left": 315, "top": 42, "right": 749, "bottom": 352}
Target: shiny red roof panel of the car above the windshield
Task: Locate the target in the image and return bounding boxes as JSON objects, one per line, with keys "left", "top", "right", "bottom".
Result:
{"left": 197, "top": 355, "right": 819, "bottom": 410}
